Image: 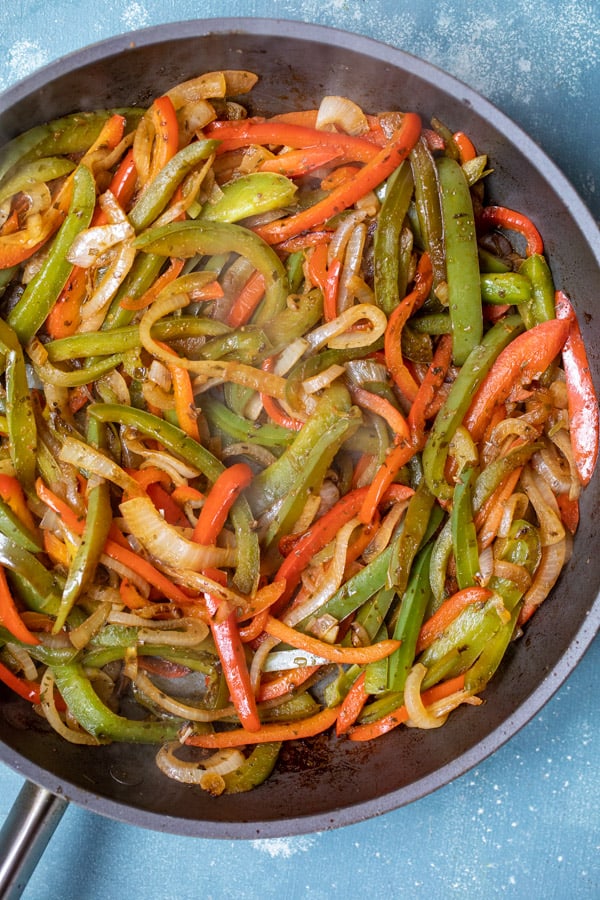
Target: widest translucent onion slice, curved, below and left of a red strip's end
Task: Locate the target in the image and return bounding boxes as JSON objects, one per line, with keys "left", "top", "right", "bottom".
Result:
{"left": 120, "top": 496, "right": 237, "bottom": 571}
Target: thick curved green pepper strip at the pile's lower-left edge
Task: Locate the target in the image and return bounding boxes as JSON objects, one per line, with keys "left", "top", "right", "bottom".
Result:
{"left": 52, "top": 662, "right": 184, "bottom": 744}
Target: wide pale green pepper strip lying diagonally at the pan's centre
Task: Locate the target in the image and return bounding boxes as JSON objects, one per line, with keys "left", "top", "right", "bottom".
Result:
{"left": 246, "top": 383, "right": 357, "bottom": 517}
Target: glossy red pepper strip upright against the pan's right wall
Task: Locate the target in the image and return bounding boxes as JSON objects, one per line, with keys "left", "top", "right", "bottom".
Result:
{"left": 556, "top": 291, "right": 599, "bottom": 486}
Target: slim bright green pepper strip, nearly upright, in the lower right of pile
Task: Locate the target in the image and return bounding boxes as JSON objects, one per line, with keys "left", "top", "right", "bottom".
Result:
{"left": 387, "top": 543, "right": 433, "bottom": 692}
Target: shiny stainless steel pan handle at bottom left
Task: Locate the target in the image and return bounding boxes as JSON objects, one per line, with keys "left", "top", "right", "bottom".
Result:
{"left": 0, "top": 781, "right": 68, "bottom": 900}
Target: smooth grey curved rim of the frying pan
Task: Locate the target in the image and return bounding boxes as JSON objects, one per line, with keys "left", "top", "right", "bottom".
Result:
{"left": 0, "top": 18, "right": 600, "bottom": 839}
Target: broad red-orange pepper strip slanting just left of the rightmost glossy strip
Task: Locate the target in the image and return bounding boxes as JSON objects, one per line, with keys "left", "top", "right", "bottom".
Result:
{"left": 464, "top": 319, "right": 570, "bottom": 443}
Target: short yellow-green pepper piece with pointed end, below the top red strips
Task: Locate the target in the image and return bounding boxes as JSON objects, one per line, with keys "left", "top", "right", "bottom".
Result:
{"left": 198, "top": 172, "right": 298, "bottom": 222}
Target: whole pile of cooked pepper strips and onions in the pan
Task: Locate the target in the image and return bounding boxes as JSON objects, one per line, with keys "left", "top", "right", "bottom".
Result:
{"left": 0, "top": 71, "right": 598, "bottom": 795}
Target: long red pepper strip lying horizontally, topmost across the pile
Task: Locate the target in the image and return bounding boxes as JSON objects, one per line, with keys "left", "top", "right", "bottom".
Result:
{"left": 204, "top": 119, "right": 378, "bottom": 162}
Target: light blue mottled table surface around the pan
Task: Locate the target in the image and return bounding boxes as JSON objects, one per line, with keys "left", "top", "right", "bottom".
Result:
{"left": 0, "top": 0, "right": 600, "bottom": 900}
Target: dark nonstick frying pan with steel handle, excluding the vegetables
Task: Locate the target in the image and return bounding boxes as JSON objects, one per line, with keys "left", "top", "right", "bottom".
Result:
{"left": 0, "top": 19, "right": 600, "bottom": 896}
